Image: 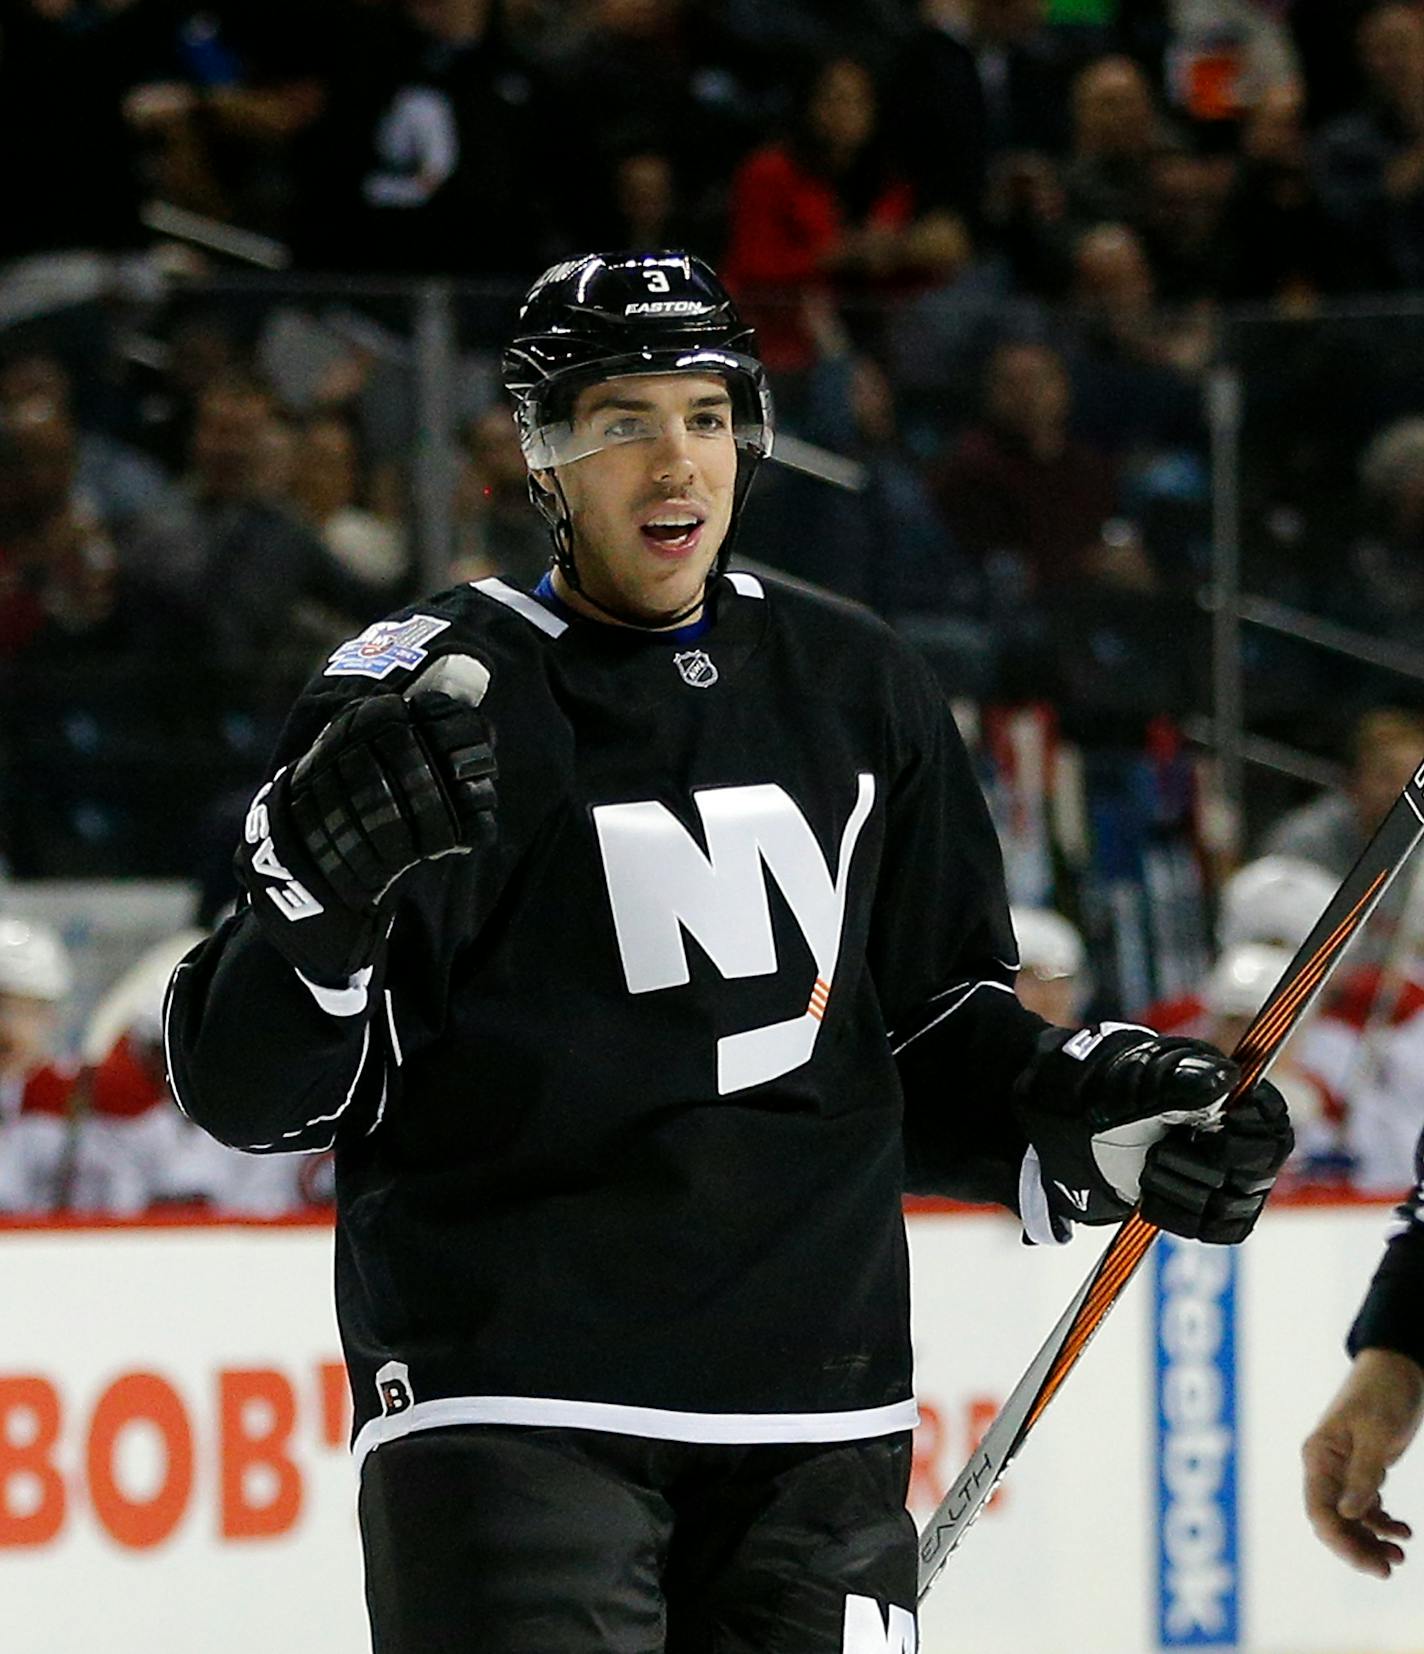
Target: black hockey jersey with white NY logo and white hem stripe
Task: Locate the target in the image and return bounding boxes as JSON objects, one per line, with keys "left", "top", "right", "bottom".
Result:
{"left": 167, "top": 572, "right": 1044, "bottom": 1452}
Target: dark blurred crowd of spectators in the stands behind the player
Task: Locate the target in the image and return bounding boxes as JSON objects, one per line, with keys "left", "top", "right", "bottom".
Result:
{"left": 11, "top": 0, "right": 1424, "bottom": 1202}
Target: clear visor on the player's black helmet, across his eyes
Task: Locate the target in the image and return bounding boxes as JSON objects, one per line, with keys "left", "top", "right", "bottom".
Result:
{"left": 523, "top": 351, "right": 772, "bottom": 471}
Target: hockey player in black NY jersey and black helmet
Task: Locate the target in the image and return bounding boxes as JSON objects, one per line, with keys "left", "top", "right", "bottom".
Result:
{"left": 167, "top": 253, "right": 1290, "bottom": 1654}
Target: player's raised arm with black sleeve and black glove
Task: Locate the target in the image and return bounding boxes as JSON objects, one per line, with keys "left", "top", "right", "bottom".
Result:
{"left": 167, "top": 641, "right": 495, "bottom": 1151}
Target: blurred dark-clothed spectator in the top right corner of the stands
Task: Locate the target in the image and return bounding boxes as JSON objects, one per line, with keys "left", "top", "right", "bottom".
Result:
{"left": 1316, "top": 0, "right": 1424, "bottom": 291}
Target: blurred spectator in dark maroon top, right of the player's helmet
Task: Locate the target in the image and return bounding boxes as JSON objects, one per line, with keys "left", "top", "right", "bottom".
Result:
{"left": 933, "top": 342, "right": 1131, "bottom": 595}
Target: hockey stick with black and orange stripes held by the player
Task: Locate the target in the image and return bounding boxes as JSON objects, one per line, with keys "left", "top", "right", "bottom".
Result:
{"left": 920, "top": 764, "right": 1424, "bottom": 1601}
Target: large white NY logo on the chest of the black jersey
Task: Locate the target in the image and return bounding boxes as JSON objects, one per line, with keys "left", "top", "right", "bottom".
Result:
{"left": 594, "top": 776, "right": 875, "bottom": 1097}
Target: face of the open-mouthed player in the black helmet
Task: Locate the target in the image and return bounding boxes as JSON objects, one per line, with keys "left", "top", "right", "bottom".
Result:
{"left": 545, "top": 374, "right": 736, "bottom": 622}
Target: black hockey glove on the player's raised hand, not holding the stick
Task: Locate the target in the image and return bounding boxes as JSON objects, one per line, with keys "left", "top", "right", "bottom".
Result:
{"left": 237, "top": 690, "right": 496, "bottom": 986}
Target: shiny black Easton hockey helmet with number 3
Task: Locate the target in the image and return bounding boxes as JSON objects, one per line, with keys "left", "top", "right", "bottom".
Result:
{"left": 503, "top": 251, "right": 772, "bottom": 590}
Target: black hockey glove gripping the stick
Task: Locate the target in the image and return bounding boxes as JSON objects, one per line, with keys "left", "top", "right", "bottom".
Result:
{"left": 1014, "top": 1024, "right": 1293, "bottom": 1244}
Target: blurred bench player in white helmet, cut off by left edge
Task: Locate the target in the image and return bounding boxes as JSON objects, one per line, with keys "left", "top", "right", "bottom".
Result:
{"left": 0, "top": 918, "right": 73, "bottom": 1214}
